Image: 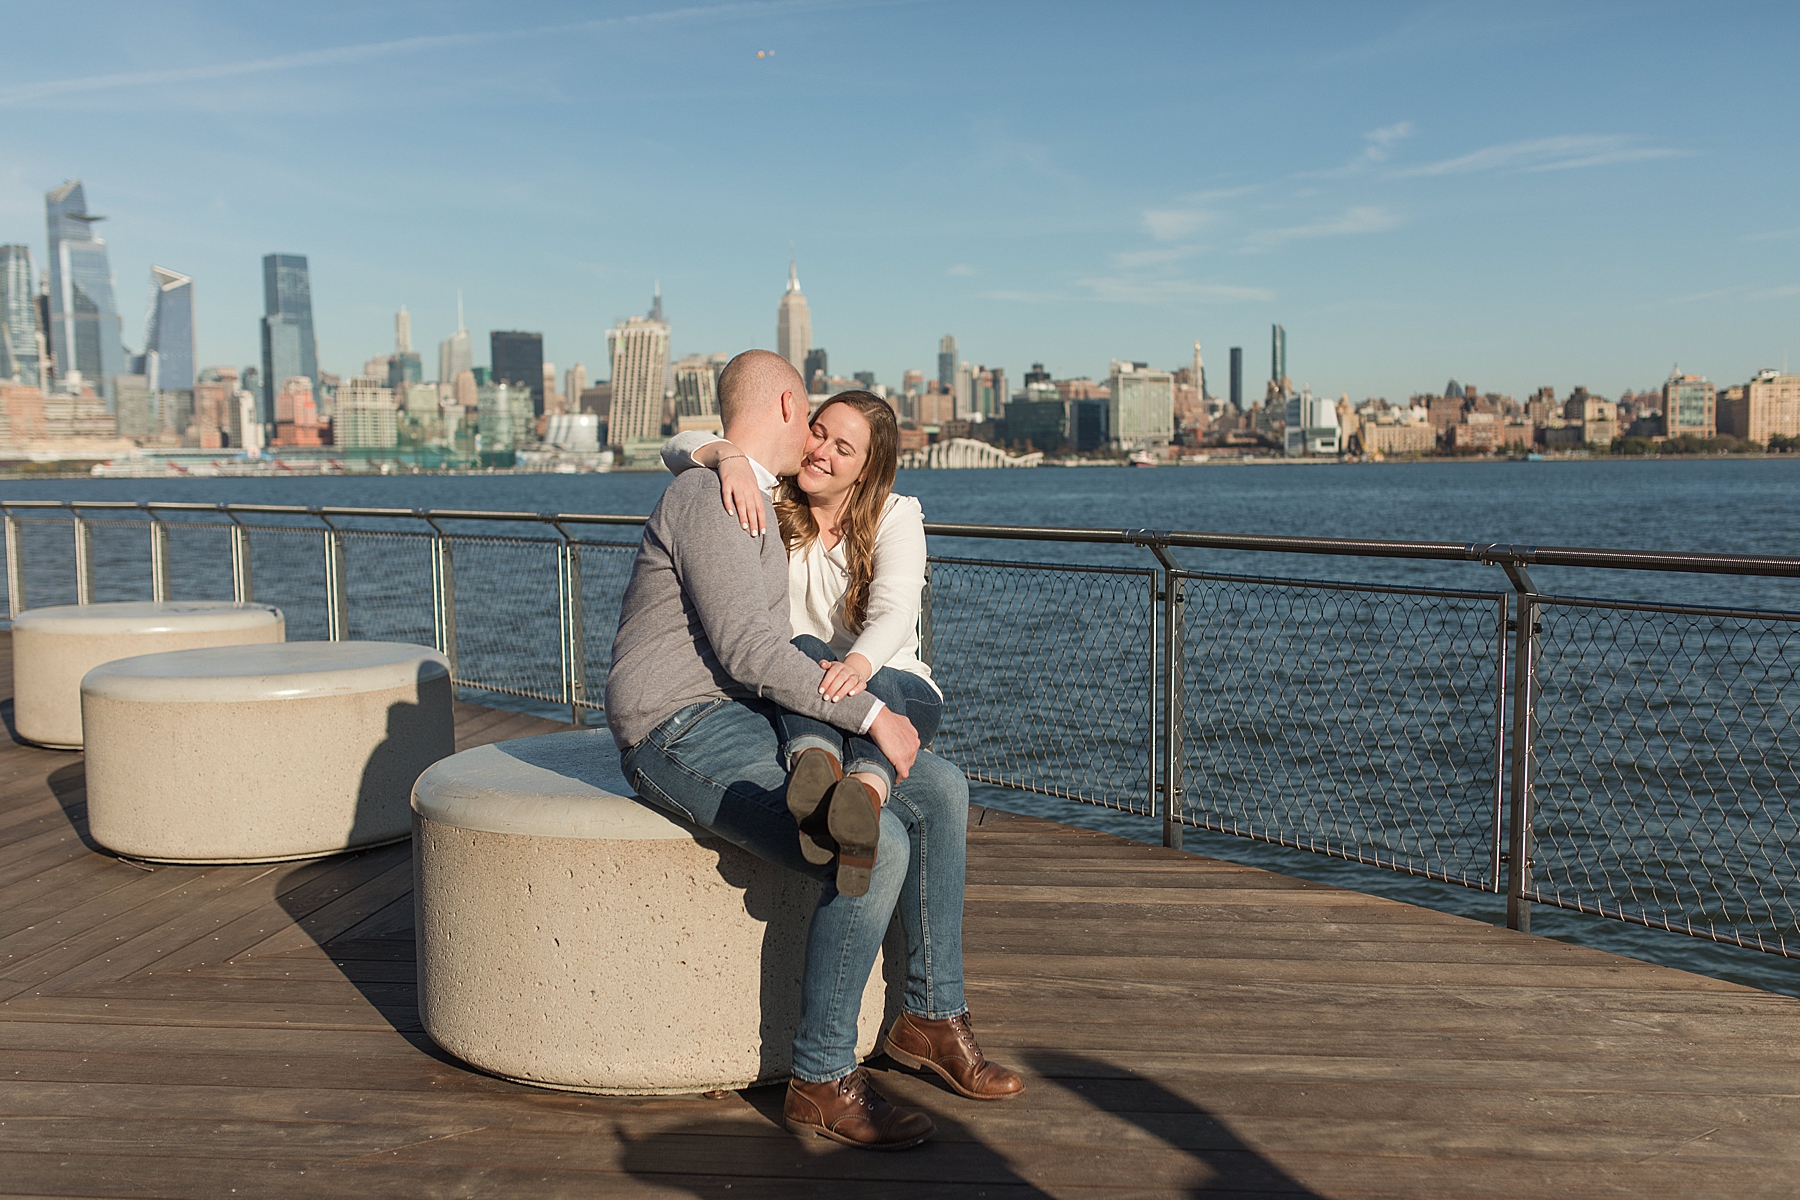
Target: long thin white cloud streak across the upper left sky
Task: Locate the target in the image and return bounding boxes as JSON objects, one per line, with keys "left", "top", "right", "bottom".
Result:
{"left": 0, "top": 0, "right": 868, "bottom": 106}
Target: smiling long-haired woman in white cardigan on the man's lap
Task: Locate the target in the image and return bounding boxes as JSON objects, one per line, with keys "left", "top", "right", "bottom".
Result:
{"left": 662, "top": 392, "right": 943, "bottom": 896}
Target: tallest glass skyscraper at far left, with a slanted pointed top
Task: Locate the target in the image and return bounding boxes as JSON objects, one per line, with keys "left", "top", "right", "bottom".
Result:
{"left": 43, "top": 180, "right": 124, "bottom": 402}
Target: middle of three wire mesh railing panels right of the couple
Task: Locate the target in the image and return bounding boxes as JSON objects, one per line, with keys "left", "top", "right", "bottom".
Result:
{"left": 1175, "top": 572, "right": 1510, "bottom": 891}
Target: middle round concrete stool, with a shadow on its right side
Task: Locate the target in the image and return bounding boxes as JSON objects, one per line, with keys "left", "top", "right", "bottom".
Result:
{"left": 81, "top": 642, "right": 455, "bottom": 862}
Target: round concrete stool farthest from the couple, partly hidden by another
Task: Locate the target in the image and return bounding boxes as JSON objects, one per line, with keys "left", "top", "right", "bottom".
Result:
{"left": 13, "top": 601, "right": 286, "bottom": 750}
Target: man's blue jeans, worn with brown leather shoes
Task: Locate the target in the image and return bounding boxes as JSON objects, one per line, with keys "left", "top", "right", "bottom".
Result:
{"left": 623, "top": 700, "right": 968, "bottom": 1083}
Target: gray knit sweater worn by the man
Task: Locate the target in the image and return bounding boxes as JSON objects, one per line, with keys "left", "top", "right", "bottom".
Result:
{"left": 607, "top": 471, "right": 875, "bottom": 750}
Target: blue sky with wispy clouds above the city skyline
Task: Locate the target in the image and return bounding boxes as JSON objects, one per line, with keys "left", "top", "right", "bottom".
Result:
{"left": 0, "top": 0, "right": 1800, "bottom": 398}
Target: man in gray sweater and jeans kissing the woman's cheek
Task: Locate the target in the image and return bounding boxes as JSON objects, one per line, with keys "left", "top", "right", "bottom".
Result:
{"left": 607, "top": 351, "right": 1024, "bottom": 1150}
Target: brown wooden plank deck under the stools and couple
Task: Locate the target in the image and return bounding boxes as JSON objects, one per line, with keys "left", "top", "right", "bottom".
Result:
{"left": 0, "top": 637, "right": 1800, "bottom": 1200}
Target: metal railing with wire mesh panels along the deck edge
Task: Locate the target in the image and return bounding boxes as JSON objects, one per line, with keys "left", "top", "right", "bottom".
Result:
{"left": 10, "top": 502, "right": 1800, "bottom": 957}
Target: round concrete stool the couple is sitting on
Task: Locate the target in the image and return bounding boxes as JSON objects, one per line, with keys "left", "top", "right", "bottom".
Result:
{"left": 412, "top": 730, "right": 902, "bottom": 1096}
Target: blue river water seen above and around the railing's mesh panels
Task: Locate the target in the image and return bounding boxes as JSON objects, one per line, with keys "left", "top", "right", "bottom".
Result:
{"left": 0, "top": 455, "right": 1800, "bottom": 995}
